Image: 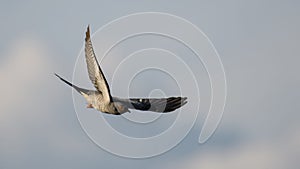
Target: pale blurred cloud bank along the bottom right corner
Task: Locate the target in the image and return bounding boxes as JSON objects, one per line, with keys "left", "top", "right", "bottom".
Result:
{"left": 163, "top": 130, "right": 300, "bottom": 169}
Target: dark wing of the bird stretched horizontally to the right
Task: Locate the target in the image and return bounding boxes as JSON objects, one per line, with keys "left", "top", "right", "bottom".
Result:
{"left": 113, "top": 97, "right": 187, "bottom": 113}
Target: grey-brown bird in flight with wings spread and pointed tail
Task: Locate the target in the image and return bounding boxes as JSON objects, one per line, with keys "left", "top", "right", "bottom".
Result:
{"left": 54, "top": 26, "right": 187, "bottom": 115}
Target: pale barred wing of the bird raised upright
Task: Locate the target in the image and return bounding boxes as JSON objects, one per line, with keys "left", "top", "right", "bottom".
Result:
{"left": 85, "top": 26, "right": 111, "bottom": 102}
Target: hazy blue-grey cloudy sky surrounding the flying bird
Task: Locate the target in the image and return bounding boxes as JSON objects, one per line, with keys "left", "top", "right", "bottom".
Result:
{"left": 0, "top": 0, "right": 300, "bottom": 169}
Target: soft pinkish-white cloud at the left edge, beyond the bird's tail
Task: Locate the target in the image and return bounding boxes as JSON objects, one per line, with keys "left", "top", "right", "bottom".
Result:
{"left": 0, "top": 39, "right": 51, "bottom": 153}
